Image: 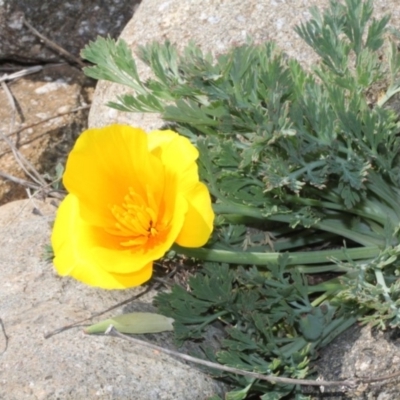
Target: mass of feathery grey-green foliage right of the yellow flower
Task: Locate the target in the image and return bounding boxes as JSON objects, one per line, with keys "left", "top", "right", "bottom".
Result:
{"left": 83, "top": 0, "right": 400, "bottom": 399}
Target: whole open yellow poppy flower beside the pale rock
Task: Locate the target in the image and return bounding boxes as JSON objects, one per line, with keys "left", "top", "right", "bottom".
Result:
{"left": 52, "top": 125, "right": 214, "bottom": 289}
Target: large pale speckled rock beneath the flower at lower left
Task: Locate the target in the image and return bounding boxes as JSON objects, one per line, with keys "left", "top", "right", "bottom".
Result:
{"left": 0, "top": 199, "right": 225, "bottom": 400}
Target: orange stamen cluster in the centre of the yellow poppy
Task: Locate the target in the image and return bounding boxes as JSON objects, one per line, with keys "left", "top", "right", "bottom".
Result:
{"left": 109, "top": 188, "right": 159, "bottom": 246}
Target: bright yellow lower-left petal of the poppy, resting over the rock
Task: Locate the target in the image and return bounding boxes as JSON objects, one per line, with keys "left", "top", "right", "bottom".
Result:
{"left": 51, "top": 194, "right": 152, "bottom": 289}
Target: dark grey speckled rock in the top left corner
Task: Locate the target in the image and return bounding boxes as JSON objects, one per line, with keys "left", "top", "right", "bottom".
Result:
{"left": 0, "top": 0, "right": 140, "bottom": 62}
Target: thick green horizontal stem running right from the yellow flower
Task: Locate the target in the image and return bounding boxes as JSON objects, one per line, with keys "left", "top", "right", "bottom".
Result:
{"left": 171, "top": 244, "right": 380, "bottom": 272}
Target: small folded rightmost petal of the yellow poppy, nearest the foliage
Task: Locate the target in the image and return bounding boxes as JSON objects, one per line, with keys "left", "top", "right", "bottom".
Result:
{"left": 176, "top": 182, "right": 214, "bottom": 247}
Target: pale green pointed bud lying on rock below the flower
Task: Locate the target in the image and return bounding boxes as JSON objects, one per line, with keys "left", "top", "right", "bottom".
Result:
{"left": 84, "top": 312, "right": 174, "bottom": 334}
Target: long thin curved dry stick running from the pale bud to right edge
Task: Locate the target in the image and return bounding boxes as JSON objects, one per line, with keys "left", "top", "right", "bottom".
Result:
{"left": 105, "top": 325, "right": 400, "bottom": 388}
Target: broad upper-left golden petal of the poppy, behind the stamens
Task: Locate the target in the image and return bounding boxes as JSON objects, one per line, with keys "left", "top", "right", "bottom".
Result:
{"left": 63, "top": 125, "right": 163, "bottom": 226}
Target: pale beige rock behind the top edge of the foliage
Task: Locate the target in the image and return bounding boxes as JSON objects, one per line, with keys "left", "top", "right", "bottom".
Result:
{"left": 89, "top": 0, "right": 400, "bottom": 130}
